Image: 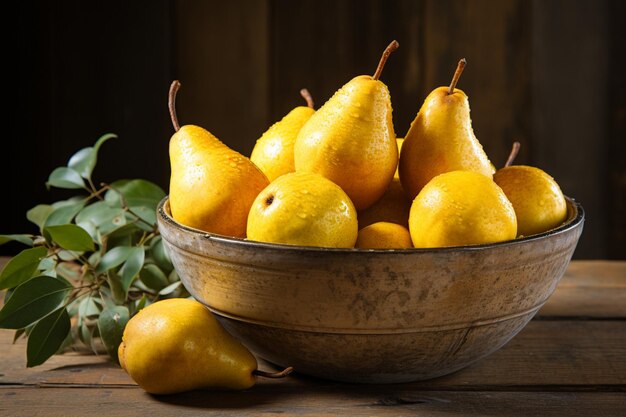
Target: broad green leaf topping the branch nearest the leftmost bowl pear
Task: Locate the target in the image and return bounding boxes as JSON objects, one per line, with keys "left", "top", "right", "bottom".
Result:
{"left": 104, "top": 179, "right": 165, "bottom": 210}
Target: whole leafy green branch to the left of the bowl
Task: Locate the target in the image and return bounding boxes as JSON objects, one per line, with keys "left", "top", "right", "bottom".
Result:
{"left": 0, "top": 134, "right": 188, "bottom": 367}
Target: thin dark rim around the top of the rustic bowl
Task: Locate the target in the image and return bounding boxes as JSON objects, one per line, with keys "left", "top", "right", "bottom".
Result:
{"left": 157, "top": 195, "right": 585, "bottom": 254}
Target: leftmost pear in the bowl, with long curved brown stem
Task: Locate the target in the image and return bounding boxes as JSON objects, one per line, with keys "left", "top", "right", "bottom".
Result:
{"left": 169, "top": 80, "right": 269, "bottom": 237}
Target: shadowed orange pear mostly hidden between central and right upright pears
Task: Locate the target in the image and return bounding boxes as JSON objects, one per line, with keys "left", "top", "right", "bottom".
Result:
{"left": 358, "top": 138, "right": 411, "bottom": 229}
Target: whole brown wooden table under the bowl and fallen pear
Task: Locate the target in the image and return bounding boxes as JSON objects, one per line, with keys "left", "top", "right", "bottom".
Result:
{"left": 0, "top": 261, "right": 626, "bottom": 417}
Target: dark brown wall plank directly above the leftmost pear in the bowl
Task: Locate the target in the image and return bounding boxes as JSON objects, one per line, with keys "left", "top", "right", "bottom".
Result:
{"left": 172, "top": 0, "right": 269, "bottom": 155}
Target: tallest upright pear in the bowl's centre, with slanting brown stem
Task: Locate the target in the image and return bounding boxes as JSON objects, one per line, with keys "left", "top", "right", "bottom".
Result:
{"left": 294, "top": 41, "right": 398, "bottom": 210}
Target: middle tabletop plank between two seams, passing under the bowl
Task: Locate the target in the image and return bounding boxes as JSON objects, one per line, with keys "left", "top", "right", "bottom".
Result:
{"left": 0, "top": 320, "right": 626, "bottom": 390}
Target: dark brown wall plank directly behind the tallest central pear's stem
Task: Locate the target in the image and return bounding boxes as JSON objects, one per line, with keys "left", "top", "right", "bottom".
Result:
{"left": 271, "top": 0, "right": 423, "bottom": 143}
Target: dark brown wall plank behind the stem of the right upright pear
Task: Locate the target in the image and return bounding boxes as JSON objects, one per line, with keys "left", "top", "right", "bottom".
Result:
{"left": 415, "top": 0, "right": 533, "bottom": 167}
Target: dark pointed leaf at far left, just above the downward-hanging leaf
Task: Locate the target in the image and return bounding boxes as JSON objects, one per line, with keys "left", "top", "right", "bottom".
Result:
{"left": 0, "top": 275, "right": 71, "bottom": 329}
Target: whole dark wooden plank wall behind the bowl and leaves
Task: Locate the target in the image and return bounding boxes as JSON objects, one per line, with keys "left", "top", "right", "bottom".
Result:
{"left": 0, "top": 0, "right": 626, "bottom": 259}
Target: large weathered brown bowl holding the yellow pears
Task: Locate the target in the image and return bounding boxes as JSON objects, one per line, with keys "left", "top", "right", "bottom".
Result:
{"left": 157, "top": 197, "right": 584, "bottom": 383}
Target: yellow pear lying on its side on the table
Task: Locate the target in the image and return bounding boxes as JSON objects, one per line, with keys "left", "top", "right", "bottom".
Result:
{"left": 118, "top": 298, "right": 292, "bottom": 394}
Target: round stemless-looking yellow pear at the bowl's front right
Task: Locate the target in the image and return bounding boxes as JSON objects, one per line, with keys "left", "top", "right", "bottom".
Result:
{"left": 409, "top": 171, "right": 517, "bottom": 248}
